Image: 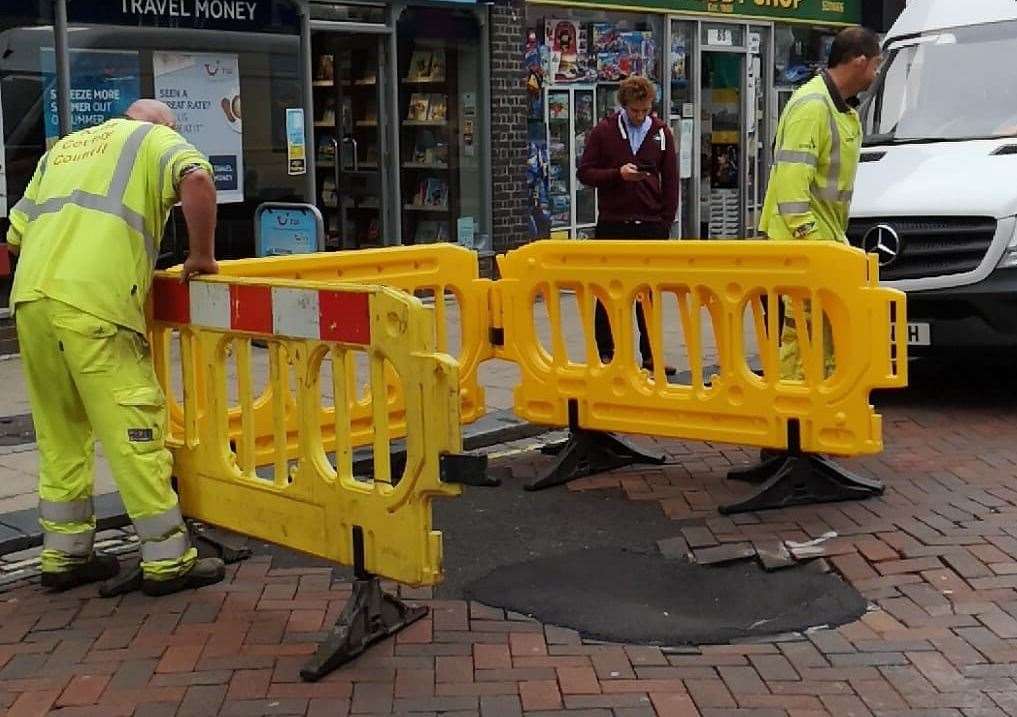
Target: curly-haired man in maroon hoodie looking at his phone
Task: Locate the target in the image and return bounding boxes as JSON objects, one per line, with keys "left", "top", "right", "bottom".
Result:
{"left": 579, "top": 77, "right": 678, "bottom": 375}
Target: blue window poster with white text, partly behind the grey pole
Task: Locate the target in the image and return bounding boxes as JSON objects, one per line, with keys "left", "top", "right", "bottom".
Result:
{"left": 42, "top": 48, "right": 141, "bottom": 144}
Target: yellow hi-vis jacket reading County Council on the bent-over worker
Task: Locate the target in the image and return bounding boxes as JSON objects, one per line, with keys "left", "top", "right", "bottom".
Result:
{"left": 7, "top": 119, "right": 212, "bottom": 334}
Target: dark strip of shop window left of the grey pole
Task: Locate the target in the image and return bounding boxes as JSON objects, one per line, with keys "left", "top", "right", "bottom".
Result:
{"left": 0, "top": 2, "right": 53, "bottom": 309}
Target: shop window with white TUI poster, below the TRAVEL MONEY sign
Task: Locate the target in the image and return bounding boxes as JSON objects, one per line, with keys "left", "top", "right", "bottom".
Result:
{"left": 58, "top": 0, "right": 303, "bottom": 264}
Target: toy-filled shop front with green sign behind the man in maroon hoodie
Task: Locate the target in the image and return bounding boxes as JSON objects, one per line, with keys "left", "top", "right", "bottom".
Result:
{"left": 524, "top": 0, "right": 860, "bottom": 239}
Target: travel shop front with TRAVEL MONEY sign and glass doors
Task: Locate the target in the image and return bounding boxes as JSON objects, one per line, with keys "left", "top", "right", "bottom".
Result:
{"left": 0, "top": 0, "right": 491, "bottom": 310}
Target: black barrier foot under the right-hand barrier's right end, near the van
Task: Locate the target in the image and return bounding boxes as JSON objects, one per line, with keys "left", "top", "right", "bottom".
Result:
{"left": 719, "top": 421, "right": 884, "bottom": 516}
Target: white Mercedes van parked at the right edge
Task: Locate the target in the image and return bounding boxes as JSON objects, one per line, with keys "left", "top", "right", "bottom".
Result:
{"left": 848, "top": 0, "right": 1017, "bottom": 354}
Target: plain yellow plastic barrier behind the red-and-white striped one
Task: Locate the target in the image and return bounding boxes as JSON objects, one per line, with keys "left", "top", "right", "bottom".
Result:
{"left": 152, "top": 244, "right": 493, "bottom": 469}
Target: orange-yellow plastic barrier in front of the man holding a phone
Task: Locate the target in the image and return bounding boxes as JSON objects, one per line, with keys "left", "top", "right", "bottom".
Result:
{"left": 493, "top": 241, "right": 907, "bottom": 455}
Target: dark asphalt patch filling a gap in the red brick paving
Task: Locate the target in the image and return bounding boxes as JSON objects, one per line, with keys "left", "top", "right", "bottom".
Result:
{"left": 255, "top": 454, "right": 865, "bottom": 645}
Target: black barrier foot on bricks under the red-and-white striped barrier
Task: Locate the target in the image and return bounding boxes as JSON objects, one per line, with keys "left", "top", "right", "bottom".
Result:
{"left": 300, "top": 526, "right": 428, "bottom": 682}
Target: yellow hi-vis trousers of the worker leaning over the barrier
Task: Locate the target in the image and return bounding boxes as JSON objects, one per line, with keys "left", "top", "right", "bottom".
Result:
{"left": 14, "top": 298, "right": 197, "bottom": 580}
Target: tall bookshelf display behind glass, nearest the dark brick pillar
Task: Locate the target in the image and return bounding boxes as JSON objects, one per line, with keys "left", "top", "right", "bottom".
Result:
{"left": 400, "top": 40, "right": 459, "bottom": 244}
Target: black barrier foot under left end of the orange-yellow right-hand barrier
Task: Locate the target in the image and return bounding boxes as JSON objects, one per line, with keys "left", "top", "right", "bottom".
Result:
{"left": 526, "top": 401, "right": 666, "bottom": 490}
